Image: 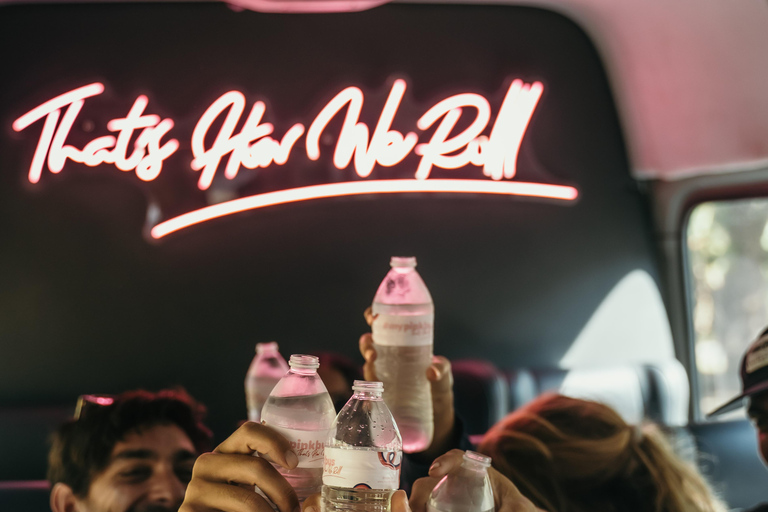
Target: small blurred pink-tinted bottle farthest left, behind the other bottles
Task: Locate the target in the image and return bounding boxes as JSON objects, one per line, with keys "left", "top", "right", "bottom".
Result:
{"left": 245, "top": 341, "right": 288, "bottom": 422}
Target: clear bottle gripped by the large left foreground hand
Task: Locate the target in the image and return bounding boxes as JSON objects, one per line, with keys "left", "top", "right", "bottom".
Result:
{"left": 261, "top": 354, "right": 336, "bottom": 502}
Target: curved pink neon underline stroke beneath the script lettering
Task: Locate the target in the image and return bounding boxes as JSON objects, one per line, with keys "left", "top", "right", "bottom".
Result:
{"left": 150, "top": 179, "right": 579, "bottom": 239}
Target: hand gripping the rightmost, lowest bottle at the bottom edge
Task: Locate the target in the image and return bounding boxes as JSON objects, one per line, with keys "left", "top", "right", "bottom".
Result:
{"left": 411, "top": 450, "right": 540, "bottom": 512}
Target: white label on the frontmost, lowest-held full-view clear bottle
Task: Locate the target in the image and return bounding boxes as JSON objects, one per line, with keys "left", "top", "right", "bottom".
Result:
{"left": 323, "top": 447, "right": 403, "bottom": 489}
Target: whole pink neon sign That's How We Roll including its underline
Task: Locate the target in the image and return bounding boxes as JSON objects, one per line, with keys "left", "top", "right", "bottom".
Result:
{"left": 13, "top": 79, "right": 578, "bottom": 238}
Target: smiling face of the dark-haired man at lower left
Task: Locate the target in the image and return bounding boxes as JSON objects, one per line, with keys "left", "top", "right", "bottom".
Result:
{"left": 76, "top": 424, "right": 196, "bottom": 512}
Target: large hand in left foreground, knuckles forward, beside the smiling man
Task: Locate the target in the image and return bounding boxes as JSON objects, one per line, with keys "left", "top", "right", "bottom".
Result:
{"left": 179, "top": 421, "right": 300, "bottom": 512}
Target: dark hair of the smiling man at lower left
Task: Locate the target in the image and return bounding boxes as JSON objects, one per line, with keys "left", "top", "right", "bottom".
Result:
{"left": 48, "top": 388, "right": 212, "bottom": 498}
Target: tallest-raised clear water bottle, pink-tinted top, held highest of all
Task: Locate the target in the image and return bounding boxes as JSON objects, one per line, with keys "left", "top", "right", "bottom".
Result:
{"left": 371, "top": 256, "right": 435, "bottom": 453}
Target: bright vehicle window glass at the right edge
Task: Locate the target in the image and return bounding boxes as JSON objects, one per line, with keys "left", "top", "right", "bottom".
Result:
{"left": 686, "top": 199, "right": 768, "bottom": 414}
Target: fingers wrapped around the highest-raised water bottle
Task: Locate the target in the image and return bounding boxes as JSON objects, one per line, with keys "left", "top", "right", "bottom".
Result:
{"left": 360, "top": 308, "right": 456, "bottom": 461}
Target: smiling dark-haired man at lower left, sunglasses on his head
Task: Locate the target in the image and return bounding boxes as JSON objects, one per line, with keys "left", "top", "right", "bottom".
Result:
{"left": 48, "top": 390, "right": 211, "bottom": 512}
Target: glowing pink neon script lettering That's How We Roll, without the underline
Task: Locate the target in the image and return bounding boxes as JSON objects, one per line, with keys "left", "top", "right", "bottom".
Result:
{"left": 13, "top": 79, "right": 543, "bottom": 190}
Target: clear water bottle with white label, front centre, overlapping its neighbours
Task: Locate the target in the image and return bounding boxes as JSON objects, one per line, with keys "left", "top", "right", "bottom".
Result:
{"left": 322, "top": 380, "right": 403, "bottom": 512}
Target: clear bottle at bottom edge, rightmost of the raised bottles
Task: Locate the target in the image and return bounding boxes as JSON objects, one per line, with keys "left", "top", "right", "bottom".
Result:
{"left": 427, "top": 451, "right": 493, "bottom": 512}
